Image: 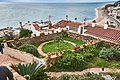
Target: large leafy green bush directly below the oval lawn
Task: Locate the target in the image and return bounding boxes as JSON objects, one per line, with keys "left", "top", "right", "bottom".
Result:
{"left": 50, "top": 51, "right": 87, "bottom": 71}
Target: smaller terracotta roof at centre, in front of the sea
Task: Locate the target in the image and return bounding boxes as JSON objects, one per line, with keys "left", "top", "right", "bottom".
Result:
{"left": 53, "top": 20, "right": 82, "bottom": 28}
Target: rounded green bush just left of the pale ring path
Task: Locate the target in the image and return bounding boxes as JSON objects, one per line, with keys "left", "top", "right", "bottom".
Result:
{"left": 18, "top": 44, "right": 40, "bottom": 57}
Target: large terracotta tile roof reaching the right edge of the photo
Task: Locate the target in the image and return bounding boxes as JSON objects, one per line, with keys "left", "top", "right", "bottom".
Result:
{"left": 85, "top": 26, "right": 120, "bottom": 43}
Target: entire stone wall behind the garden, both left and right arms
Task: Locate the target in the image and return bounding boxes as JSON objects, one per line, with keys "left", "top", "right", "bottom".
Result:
{"left": 7, "top": 32, "right": 120, "bottom": 49}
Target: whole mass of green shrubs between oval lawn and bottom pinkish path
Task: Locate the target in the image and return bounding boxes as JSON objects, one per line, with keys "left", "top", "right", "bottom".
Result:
{"left": 49, "top": 43, "right": 120, "bottom": 72}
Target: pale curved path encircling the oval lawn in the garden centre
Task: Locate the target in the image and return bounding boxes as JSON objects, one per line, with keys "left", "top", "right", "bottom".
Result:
{"left": 37, "top": 40, "right": 76, "bottom": 58}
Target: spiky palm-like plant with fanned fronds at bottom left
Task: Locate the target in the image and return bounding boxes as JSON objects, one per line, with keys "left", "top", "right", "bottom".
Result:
{"left": 11, "top": 63, "right": 47, "bottom": 80}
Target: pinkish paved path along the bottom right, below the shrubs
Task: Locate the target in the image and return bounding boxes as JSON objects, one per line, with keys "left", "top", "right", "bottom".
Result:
{"left": 47, "top": 68, "right": 120, "bottom": 77}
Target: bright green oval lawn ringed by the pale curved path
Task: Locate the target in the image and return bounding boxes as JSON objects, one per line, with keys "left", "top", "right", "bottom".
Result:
{"left": 42, "top": 42, "right": 74, "bottom": 54}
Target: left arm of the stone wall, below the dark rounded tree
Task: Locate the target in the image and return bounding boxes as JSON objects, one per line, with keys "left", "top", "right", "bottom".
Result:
{"left": 7, "top": 32, "right": 63, "bottom": 47}
